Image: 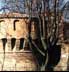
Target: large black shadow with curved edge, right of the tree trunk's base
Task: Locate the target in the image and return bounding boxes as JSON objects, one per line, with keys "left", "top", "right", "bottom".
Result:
{"left": 47, "top": 45, "right": 61, "bottom": 70}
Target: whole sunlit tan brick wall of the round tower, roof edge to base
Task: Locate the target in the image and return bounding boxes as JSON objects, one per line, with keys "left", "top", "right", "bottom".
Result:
{"left": 0, "top": 14, "right": 38, "bottom": 71}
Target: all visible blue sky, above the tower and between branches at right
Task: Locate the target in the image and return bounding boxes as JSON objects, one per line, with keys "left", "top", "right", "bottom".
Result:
{"left": 0, "top": 0, "right": 69, "bottom": 13}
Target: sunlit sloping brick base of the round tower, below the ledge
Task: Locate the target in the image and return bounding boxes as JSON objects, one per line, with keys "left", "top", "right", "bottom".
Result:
{"left": 0, "top": 52, "right": 38, "bottom": 71}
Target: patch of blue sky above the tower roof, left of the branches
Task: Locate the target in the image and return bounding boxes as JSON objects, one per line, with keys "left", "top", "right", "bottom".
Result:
{"left": 0, "top": 0, "right": 24, "bottom": 13}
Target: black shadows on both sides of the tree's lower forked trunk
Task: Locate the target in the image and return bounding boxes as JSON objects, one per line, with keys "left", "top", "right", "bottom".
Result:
{"left": 33, "top": 39, "right": 61, "bottom": 71}
